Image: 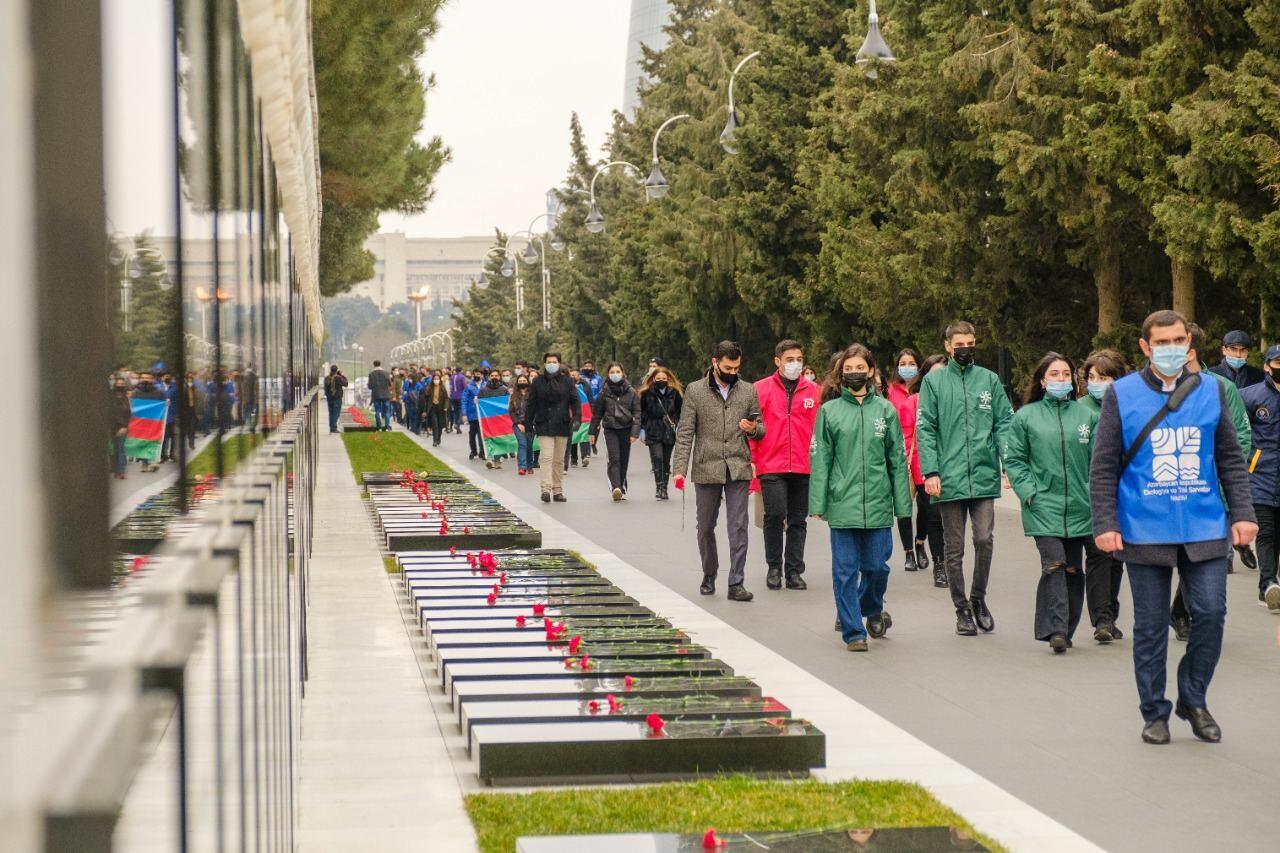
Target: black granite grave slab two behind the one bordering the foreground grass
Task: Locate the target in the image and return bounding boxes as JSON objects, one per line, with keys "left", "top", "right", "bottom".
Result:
{"left": 453, "top": 675, "right": 760, "bottom": 725}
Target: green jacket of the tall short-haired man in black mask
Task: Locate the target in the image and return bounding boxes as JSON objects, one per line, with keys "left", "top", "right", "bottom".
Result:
{"left": 915, "top": 360, "right": 1014, "bottom": 503}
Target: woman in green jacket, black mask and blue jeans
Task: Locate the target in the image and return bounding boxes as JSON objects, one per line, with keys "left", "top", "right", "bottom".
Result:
{"left": 809, "top": 343, "right": 911, "bottom": 652}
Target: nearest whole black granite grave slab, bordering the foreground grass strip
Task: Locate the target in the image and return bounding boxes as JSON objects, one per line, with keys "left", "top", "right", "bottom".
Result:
{"left": 471, "top": 719, "right": 826, "bottom": 784}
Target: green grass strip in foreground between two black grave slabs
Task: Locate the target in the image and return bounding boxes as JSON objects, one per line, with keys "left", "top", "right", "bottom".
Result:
{"left": 466, "top": 776, "right": 1005, "bottom": 853}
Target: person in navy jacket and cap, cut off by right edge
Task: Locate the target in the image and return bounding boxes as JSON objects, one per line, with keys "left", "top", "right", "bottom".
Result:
{"left": 1240, "top": 343, "right": 1280, "bottom": 613}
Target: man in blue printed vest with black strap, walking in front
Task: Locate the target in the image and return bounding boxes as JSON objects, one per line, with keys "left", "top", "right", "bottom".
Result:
{"left": 1089, "top": 311, "right": 1258, "bottom": 744}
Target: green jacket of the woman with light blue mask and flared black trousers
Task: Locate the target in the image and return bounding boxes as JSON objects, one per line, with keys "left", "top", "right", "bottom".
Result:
{"left": 1004, "top": 396, "right": 1098, "bottom": 537}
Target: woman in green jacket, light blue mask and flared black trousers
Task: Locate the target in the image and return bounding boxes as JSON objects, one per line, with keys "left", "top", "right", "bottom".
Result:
{"left": 1004, "top": 352, "right": 1098, "bottom": 654}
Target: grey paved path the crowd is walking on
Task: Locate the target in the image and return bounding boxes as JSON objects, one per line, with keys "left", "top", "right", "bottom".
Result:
{"left": 426, "top": 427, "right": 1280, "bottom": 853}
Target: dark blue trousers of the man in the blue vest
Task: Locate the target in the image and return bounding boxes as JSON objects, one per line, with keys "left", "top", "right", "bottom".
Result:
{"left": 1129, "top": 549, "right": 1226, "bottom": 722}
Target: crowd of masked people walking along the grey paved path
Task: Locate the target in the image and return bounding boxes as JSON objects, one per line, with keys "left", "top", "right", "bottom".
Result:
{"left": 330, "top": 311, "right": 1280, "bottom": 743}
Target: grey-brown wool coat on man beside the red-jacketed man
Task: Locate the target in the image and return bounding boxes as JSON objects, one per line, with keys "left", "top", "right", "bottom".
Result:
{"left": 671, "top": 371, "right": 764, "bottom": 485}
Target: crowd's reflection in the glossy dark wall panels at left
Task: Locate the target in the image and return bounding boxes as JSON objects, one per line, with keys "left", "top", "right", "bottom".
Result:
{"left": 111, "top": 361, "right": 262, "bottom": 480}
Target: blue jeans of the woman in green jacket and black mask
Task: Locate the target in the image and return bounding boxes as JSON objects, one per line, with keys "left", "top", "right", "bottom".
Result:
{"left": 831, "top": 528, "right": 893, "bottom": 643}
